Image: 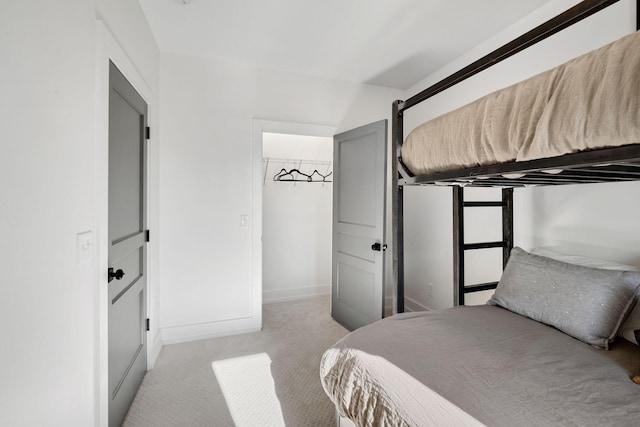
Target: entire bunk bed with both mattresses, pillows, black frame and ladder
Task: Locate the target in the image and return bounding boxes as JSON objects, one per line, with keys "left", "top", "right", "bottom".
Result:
{"left": 320, "top": 0, "right": 640, "bottom": 426}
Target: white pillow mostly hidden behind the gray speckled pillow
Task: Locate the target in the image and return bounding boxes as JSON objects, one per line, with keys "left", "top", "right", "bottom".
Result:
{"left": 531, "top": 248, "right": 640, "bottom": 345}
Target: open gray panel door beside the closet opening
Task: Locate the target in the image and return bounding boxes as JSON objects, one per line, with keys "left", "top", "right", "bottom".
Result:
{"left": 331, "top": 120, "right": 387, "bottom": 330}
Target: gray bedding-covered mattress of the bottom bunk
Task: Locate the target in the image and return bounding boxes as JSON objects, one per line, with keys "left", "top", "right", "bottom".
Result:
{"left": 320, "top": 306, "right": 640, "bottom": 426}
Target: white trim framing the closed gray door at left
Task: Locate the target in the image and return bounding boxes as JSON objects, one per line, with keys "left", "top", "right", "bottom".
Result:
{"left": 91, "top": 18, "right": 162, "bottom": 427}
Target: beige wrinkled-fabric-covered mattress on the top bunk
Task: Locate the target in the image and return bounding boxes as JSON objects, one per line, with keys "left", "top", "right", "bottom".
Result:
{"left": 402, "top": 32, "right": 640, "bottom": 175}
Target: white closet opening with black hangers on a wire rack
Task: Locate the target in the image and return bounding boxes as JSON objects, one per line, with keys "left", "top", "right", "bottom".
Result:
{"left": 262, "top": 132, "right": 333, "bottom": 303}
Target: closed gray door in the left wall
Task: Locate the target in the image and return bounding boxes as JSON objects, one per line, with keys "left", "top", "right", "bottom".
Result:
{"left": 108, "top": 64, "right": 147, "bottom": 426}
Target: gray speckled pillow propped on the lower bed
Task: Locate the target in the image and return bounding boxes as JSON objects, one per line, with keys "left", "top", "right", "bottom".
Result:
{"left": 487, "top": 248, "right": 640, "bottom": 349}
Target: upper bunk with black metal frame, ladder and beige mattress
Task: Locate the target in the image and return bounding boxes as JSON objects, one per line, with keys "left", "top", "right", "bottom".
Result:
{"left": 392, "top": 0, "right": 640, "bottom": 312}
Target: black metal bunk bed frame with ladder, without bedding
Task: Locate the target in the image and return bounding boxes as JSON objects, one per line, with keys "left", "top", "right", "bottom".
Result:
{"left": 391, "top": 0, "right": 640, "bottom": 313}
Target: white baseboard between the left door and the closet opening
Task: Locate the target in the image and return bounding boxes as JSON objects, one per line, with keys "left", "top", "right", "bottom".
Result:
{"left": 161, "top": 317, "right": 262, "bottom": 345}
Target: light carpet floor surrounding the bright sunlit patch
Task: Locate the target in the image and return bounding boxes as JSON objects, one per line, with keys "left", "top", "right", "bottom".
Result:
{"left": 124, "top": 297, "right": 348, "bottom": 427}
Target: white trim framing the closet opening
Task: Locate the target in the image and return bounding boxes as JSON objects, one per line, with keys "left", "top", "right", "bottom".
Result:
{"left": 251, "top": 119, "right": 338, "bottom": 314}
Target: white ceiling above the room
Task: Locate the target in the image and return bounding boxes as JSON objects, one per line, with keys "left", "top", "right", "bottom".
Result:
{"left": 139, "top": 0, "right": 550, "bottom": 89}
